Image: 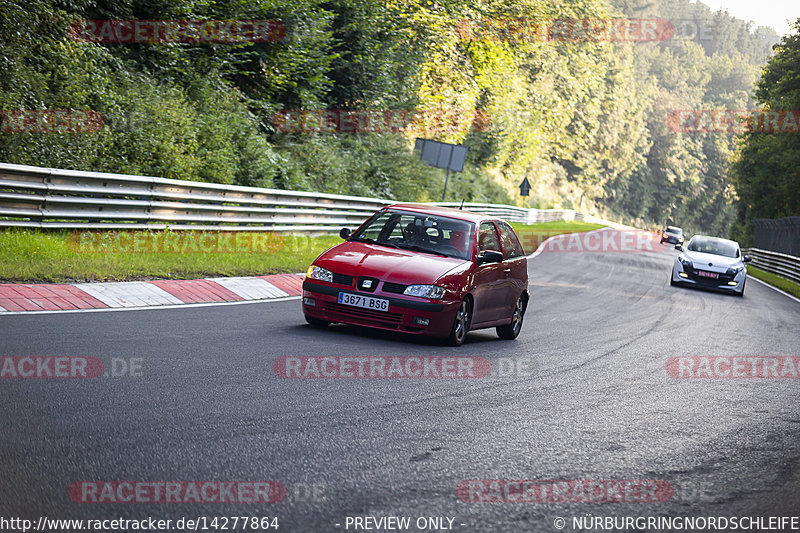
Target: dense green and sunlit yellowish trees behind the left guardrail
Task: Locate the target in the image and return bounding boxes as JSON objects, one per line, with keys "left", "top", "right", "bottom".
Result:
{"left": 0, "top": 0, "right": 788, "bottom": 233}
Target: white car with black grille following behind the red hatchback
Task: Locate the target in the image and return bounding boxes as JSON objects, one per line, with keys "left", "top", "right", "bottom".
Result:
{"left": 669, "top": 235, "right": 750, "bottom": 296}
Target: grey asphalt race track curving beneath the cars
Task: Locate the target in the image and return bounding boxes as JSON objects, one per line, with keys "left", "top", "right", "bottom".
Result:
{"left": 0, "top": 233, "right": 800, "bottom": 532}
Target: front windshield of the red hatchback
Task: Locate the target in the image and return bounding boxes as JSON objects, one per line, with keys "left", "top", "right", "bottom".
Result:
{"left": 348, "top": 210, "right": 475, "bottom": 260}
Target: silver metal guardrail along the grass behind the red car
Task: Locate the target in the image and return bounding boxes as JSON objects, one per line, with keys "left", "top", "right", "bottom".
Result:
{"left": 0, "top": 163, "right": 627, "bottom": 233}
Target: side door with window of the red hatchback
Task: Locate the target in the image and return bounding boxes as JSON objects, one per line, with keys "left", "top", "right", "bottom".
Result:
{"left": 472, "top": 222, "right": 506, "bottom": 325}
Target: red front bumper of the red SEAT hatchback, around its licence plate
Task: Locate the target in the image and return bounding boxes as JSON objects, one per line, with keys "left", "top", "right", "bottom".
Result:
{"left": 303, "top": 279, "right": 460, "bottom": 337}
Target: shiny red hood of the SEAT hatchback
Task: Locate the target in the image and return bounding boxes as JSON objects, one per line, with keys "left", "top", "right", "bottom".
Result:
{"left": 314, "top": 241, "right": 469, "bottom": 285}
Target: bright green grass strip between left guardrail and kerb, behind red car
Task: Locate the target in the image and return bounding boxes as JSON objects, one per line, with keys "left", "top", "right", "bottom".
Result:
{"left": 0, "top": 221, "right": 603, "bottom": 283}
